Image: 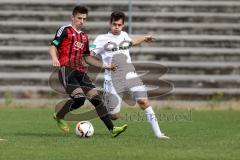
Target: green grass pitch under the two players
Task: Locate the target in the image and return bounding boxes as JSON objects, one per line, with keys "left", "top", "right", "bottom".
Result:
{"left": 0, "top": 108, "right": 240, "bottom": 160}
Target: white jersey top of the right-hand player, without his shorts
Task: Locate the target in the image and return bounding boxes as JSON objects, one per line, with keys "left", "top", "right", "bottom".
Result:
{"left": 91, "top": 31, "right": 137, "bottom": 80}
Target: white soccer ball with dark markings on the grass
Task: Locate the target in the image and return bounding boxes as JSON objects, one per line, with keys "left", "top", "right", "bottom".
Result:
{"left": 75, "top": 121, "right": 94, "bottom": 138}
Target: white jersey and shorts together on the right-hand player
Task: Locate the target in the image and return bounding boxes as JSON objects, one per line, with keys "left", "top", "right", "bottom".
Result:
{"left": 91, "top": 31, "right": 147, "bottom": 114}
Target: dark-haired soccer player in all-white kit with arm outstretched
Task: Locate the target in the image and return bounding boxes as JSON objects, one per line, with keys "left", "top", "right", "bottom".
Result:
{"left": 91, "top": 11, "right": 169, "bottom": 139}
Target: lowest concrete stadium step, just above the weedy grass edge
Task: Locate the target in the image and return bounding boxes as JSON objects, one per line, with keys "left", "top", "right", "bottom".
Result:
{"left": 0, "top": 86, "right": 240, "bottom": 101}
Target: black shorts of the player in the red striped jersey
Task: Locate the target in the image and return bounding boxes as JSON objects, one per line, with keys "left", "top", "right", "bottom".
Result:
{"left": 59, "top": 66, "right": 96, "bottom": 95}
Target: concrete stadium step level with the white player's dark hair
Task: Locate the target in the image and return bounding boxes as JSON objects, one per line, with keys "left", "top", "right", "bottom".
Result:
{"left": 0, "top": 10, "right": 240, "bottom": 23}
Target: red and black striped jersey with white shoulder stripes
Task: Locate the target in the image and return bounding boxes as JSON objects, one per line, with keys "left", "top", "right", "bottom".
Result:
{"left": 51, "top": 25, "right": 90, "bottom": 72}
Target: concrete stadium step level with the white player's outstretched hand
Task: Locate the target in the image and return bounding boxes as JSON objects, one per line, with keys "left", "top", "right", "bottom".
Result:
{"left": 0, "top": 34, "right": 240, "bottom": 48}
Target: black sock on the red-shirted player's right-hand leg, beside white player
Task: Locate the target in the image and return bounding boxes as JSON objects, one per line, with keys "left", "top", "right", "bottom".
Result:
{"left": 89, "top": 95, "right": 114, "bottom": 130}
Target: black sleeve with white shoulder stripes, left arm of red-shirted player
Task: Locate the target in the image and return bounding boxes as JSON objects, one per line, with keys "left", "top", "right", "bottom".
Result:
{"left": 51, "top": 26, "right": 67, "bottom": 48}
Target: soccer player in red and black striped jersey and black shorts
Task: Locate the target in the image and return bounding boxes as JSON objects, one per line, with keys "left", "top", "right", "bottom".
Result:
{"left": 49, "top": 6, "right": 127, "bottom": 137}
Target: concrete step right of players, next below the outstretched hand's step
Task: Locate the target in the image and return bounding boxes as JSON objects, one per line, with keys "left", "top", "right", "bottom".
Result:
{"left": 132, "top": 47, "right": 240, "bottom": 62}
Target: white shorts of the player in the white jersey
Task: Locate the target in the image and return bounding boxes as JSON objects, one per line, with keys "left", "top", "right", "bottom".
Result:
{"left": 104, "top": 80, "right": 147, "bottom": 114}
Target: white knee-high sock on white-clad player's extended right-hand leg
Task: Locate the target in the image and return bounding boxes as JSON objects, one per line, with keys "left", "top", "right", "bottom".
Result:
{"left": 144, "top": 106, "right": 162, "bottom": 137}
